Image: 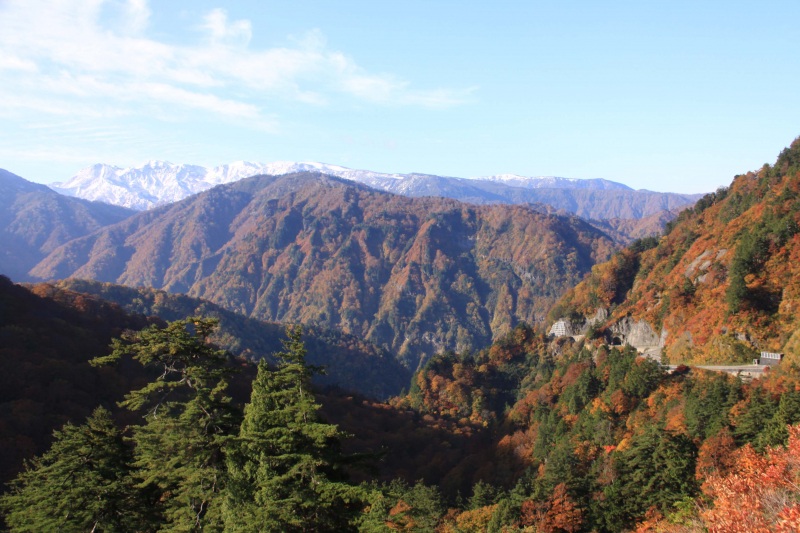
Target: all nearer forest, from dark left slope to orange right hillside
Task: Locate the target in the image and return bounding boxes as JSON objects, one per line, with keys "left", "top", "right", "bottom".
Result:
{"left": 0, "top": 140, "right": 800, "bottom": 533}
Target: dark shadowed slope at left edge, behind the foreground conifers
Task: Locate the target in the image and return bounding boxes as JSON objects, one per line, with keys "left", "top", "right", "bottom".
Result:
{"left": 0, "top": 276, "right": 152, "bottom": 484}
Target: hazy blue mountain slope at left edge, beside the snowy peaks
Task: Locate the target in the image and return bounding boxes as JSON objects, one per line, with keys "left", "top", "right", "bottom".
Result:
{"left": 0, "top": 169, "right": 134, "bottom": 281}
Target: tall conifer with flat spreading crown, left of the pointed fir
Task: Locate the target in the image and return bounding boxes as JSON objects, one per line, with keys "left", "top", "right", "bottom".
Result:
{"left": 93, "top": 317, "right": 239, "bottom": 531}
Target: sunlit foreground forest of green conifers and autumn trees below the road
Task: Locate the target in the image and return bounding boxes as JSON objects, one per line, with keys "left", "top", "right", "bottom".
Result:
{"left": 0, "top": 288, "right": 800, "bottom": 531}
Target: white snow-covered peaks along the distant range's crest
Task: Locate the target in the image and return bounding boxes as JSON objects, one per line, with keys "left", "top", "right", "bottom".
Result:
{"left": 50, "top": 161, "right": 630, "bottom": 210}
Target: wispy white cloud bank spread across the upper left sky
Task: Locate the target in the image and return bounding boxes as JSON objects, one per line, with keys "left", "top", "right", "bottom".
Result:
{"left": 0, "top": 0, "right": 473, "bottom": 130}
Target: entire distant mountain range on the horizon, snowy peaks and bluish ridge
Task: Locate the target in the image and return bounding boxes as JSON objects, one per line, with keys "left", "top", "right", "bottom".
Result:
{"left": 51, "top": 161, "right": 701, "bottom": 219}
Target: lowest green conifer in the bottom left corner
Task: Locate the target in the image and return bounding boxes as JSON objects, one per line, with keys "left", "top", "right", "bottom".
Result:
{"left": 0, "top": 407, "right": 141, "bottom": 532}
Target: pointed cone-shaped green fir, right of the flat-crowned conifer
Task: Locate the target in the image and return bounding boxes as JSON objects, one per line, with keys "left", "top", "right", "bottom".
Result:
{"left": 225, "top": 326, "right": 363, "bottom": 532}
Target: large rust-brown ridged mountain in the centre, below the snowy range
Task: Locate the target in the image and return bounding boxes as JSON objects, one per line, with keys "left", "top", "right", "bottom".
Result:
{"left": 31, "top": 173, "right": 615, "bottom": 368}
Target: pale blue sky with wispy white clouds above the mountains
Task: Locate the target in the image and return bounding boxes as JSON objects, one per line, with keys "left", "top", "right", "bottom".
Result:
{"left": 0, "top": 0, "right": 800, "bottom": 192}
